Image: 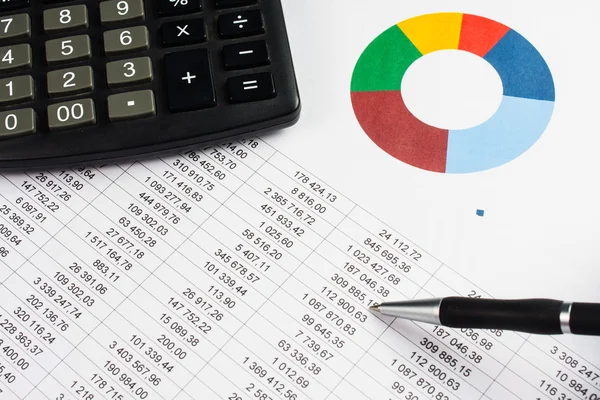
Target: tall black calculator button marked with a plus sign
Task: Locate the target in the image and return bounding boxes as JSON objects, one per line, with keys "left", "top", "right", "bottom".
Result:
{"left": 165, "top": 49, "right": 217, "bottom": 112}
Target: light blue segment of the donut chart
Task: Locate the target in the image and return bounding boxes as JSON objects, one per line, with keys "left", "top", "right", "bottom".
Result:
{"left": 446, "top": 96, "right": 554, "bottom": 174}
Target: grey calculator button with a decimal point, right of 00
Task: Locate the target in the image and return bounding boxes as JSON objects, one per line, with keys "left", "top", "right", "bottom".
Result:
{"left": 108, "top": 90, "right": 156, "bottom": 121}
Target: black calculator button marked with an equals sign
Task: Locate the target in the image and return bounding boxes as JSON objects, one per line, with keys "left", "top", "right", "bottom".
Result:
{"left": 227, "top": 72, "right": 276, "bottom": 103}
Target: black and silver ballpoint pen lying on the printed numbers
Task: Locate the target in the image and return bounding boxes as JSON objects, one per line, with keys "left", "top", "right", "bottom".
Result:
{"left": 370, "top": 297, "right": 600, "bottom": 336}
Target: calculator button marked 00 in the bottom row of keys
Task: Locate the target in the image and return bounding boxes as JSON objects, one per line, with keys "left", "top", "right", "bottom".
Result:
{"left": 48, "top": 99, "right": 96, "bottom": 131}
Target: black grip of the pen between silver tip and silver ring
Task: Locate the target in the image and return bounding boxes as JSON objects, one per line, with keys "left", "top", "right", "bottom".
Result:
{"left": 440, "top": 297, "right": 564, "bottom": 335}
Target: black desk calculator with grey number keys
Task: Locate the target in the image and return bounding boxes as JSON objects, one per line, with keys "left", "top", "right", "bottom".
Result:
{"left": 0, "top": 0, "right": 300, "bottom": 169}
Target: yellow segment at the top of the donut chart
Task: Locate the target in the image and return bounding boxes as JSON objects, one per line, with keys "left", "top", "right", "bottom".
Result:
{"left": 398, "top": 13, "right": 463, "bottom": 55}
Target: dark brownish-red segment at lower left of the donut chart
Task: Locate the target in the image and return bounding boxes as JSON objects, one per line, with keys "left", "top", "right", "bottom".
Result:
{"left": 351, "top": 90, "right": 448, "bottom": 172}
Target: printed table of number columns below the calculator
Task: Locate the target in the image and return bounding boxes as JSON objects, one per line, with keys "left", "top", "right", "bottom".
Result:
{"left": 0, "top": 139, "right": 600, "bottom": 400}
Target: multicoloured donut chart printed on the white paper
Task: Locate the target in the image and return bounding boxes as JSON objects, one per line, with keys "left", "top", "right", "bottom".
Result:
{"left": 351, "top": 13, "right": 555, "bottom": 174}
